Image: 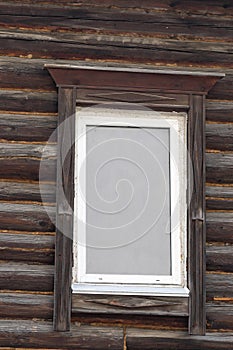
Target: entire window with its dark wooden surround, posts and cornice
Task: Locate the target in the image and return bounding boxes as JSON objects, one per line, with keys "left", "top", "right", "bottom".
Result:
{"left": 47, "top": 65, "right": 223, "bottom": 335}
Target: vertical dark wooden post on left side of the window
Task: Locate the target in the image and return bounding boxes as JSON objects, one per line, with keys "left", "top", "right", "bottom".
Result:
{"left": 54, "top": 87, "right": 76, "bottom": 331}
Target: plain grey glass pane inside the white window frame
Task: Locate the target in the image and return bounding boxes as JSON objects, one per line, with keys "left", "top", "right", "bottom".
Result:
{"left": 86, "top": 126, "right": 171, "bottom": 275}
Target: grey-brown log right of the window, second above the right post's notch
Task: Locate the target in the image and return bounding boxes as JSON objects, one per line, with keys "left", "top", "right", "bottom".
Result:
{"left": 206, "top": 153, "right": 233, "bottom": 184}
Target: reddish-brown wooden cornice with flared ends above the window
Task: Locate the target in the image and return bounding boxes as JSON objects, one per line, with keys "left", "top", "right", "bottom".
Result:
{"left": 47, "top": 65, "right": 224, "bottom": 94}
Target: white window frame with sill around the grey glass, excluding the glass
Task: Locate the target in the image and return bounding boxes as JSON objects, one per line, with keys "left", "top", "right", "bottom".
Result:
{"left": 72, "top": 107, "right": 189, "bottom": 296}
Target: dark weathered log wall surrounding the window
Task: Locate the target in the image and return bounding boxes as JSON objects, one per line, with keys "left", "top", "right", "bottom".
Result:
{"left": 0, "top": 0, "right": 233, "bottom": 349}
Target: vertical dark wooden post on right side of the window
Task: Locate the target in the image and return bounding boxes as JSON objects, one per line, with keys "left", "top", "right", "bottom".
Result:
{"left": 188, "top": 95, "right": 206, "bottom": 335}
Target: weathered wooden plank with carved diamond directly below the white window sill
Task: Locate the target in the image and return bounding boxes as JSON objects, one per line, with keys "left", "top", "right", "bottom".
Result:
{"left": 72, "top": 294, "right": 188, "bottom": 316}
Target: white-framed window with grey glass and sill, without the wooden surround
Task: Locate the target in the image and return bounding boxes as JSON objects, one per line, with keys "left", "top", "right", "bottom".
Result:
{"left": 73, "top": 107, "right": 188, "bottom": 296}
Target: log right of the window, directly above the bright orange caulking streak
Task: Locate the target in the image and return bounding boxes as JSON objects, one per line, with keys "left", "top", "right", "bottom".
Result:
{"left": 206, "top": 272, "right": 233, "bottom": 300}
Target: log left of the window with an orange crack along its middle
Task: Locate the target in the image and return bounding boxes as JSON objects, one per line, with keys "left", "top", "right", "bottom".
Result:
{"left": 0, "top": 233, "right": 55, "bottom": 264}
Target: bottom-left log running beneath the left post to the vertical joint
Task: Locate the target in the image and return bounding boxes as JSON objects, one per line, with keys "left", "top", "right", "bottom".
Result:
{"left": 0, "top": 320, "right": 123, "bottom": 350}
